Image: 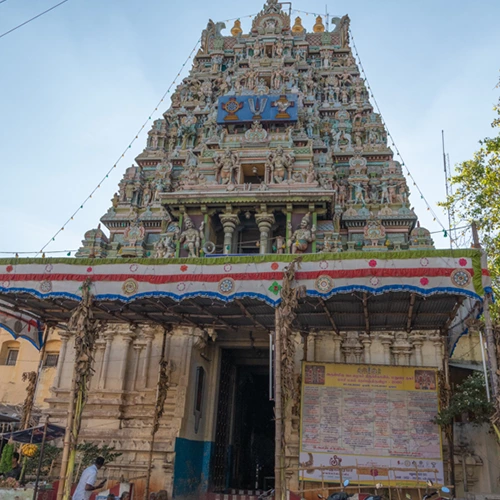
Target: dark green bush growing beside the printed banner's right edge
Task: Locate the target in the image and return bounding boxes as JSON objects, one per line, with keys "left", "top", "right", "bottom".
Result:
{"left": 434, "top": 372, "right": 495, "bottom": 426}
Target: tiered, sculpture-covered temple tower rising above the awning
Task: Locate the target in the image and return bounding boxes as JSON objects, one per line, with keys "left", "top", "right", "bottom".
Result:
{"left": 77, "top": 0, "right": 433, "bottom": 258}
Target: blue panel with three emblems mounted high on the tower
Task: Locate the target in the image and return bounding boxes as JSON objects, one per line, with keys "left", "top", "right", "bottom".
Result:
{"left": 217, "top": 94, "right": 297, "bottom": 125}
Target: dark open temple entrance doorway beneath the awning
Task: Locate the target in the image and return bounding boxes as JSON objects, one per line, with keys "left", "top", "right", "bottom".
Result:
{"left": 211, "top": 349, "right": 275, "bottom": 492}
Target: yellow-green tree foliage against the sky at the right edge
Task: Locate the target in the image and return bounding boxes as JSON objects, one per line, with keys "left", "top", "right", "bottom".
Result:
{"left": 441, "top": 77, "right": 500, "bottom": 312}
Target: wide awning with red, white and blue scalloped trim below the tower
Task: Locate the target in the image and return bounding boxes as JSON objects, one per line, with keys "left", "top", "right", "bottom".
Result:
{"left": 0, "top": 249, "right": 491, "bottom": 352}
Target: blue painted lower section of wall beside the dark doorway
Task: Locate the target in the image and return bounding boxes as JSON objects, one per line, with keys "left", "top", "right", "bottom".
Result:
{"left": 174, "top": 438, "right": 214, "bottom": 498}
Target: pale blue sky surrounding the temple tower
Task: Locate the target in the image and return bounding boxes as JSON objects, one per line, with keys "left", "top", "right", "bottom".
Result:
{"left": 0, "top": 0, "right": 500, "bottom": 252}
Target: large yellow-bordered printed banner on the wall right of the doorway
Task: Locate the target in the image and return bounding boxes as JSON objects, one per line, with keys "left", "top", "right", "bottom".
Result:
{"left": 300, "top": 363, "right": 444, "bottom": 486}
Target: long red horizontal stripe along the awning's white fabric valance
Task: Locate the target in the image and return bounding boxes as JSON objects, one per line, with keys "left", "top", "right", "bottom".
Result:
{"left": 0, "top": 267, "right": 474, "bottom": 284}
